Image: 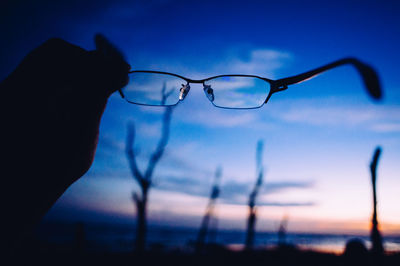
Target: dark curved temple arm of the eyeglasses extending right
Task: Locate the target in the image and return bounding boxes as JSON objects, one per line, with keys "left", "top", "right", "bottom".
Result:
{"left": 272, "top": 57, "right": 382, "bottom": 100}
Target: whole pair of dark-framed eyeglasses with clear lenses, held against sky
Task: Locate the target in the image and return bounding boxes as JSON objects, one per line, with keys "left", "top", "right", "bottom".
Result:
{"left": 119, "top": 58, "right": 382, "bottom": 109}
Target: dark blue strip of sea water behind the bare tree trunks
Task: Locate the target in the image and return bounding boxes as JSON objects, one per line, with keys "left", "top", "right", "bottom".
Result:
{"left": 37, "top": 223, "right": 400, "bottom": 254}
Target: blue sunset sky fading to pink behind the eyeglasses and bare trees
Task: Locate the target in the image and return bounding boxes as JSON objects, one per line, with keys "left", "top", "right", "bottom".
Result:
{"left": 0, "top": 1, "right": 400, "bottom": 233}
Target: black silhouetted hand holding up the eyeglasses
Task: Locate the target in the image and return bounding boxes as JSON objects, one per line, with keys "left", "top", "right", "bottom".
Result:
{"left": 0, "top": 35, "right": 130, "bottom": 241}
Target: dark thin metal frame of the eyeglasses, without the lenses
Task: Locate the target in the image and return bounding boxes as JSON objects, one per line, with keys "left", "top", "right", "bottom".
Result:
{"left": 118, "top": 57, "right": 382, "bottom": 109}
